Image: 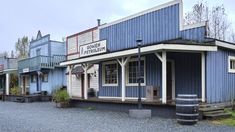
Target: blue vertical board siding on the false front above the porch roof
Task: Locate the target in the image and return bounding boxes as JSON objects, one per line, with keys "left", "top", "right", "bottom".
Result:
{"left": 100, "top": 4, "right": 205, "bottom": 52}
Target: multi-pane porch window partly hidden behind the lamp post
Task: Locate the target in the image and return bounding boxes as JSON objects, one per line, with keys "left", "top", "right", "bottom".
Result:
{"left": 126, "top": 58, "right": 145, "bottom": 86}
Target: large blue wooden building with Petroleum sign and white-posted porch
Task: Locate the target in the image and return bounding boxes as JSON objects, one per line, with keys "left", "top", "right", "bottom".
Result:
{"left": 61, "top": 0, "right": 235, "bottom": 104}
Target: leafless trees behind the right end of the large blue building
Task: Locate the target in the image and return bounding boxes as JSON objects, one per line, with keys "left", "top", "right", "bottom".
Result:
{"left": 185, "top": 0, "right": 231, "bottom": 40}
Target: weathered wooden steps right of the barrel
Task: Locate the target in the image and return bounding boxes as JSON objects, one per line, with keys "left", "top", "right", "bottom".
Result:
{"left": 199, "top": 104, "right": 232, "bottom": 120}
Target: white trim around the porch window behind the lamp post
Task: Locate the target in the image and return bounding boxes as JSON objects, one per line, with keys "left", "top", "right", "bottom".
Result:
{"left": 126, "top": 57, "right": 146, "bottom": 86}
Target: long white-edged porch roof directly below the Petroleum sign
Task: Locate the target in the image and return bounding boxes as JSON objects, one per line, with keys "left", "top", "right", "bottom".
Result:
{"left": 60, "top": 40, "right": 217, "bottom": 66}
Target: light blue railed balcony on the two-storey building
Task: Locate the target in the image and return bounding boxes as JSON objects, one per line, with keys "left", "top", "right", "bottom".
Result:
{"left": 18, "top": 55, "right": 66, "bottom": 73}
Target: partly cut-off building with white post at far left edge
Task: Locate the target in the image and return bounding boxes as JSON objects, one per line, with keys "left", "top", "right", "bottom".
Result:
{"left": 0, "top": 53, "right": 17, "bottom": 95}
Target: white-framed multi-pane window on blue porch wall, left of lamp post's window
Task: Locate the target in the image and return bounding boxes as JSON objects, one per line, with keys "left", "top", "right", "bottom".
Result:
{"left": 102, "top": 62, "right": 118, "bottom": 86}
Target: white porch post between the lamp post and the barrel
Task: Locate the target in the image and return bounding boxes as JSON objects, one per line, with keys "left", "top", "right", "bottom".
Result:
{"left": 162, "top": 51, "right": 167, "bottom": 104}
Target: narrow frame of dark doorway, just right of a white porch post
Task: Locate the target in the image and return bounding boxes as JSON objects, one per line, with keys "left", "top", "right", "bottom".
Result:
{"left": 167, "top": 59, "right": 175, "bottom": 100}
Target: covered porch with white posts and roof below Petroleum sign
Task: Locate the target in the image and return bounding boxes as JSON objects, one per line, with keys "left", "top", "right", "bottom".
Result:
{"left": 61, "top": 43, "right": 217, "bottom": 104}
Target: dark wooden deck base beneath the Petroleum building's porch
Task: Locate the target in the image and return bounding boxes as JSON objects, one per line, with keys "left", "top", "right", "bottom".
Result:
{"left": 71, "top": 97, "right": 175, "bottom": 106}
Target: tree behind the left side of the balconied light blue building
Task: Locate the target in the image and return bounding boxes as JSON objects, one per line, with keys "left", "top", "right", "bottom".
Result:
{"left": 15, "top": 36, "right": 29, "bottom": 59}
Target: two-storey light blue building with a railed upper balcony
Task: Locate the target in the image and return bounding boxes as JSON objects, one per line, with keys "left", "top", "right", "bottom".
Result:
{"left": 18, "top": 31, "right": 66, "bottom": 94}
